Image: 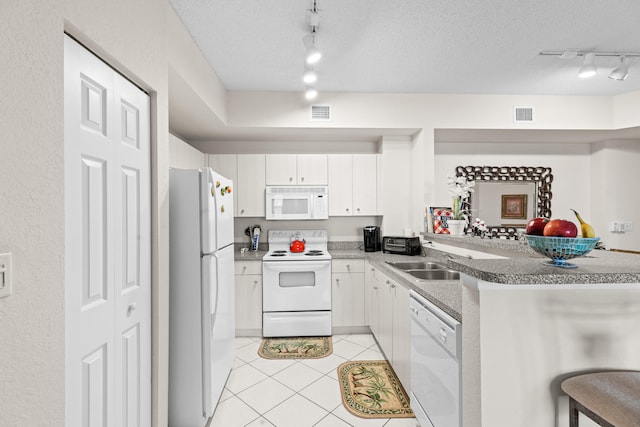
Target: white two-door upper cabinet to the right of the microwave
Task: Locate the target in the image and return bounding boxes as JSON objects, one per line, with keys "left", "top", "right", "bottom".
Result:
{"left": 327, "top": 154, "right": 378, "bottom": 216}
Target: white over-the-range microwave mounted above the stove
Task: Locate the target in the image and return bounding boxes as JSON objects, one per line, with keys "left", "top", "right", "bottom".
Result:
{"left": 265, "top": 185, "right": 329, "bottom": 220}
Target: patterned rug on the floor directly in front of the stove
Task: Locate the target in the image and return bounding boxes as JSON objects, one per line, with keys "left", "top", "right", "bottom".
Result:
{"left": 258, "top": 337, "right": 333, "bottom": 359}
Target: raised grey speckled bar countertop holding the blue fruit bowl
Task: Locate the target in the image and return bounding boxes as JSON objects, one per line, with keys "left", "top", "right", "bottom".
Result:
{"left": 425, "top": 234, "right": 640, "bottom": 285}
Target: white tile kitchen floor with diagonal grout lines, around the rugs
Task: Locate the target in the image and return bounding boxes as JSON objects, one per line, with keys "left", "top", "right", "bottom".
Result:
{"left": 210, "top": 334, "right": 419, "bottom": 427}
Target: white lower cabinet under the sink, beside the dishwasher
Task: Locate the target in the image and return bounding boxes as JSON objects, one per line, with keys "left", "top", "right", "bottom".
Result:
{"left": 366, "top": 263, "right": 411, "bottom": 390}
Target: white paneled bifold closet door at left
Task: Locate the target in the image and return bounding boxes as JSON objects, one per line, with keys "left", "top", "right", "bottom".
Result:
{"left": 64, "top": 36, "right": 151, "bottom": 426}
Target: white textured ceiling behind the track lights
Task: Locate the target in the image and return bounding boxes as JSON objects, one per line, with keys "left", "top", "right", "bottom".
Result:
{"left": 170, "top": 0, "right": 640, "bottom": 95}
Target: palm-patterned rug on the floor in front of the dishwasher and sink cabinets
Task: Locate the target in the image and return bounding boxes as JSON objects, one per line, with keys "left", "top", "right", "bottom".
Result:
{"left": 338, "top": 360, "right": 415, "bottom": 418}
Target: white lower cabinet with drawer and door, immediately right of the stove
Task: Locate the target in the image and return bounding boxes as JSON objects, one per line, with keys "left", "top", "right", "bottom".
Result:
{"left": 331, "top": 259, "right": 367, "bottom": 333}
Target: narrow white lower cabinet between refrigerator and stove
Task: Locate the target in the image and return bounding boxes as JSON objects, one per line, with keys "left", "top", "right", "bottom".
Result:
{"left": 235, "top": 261, "right": 262, "bottom": 336}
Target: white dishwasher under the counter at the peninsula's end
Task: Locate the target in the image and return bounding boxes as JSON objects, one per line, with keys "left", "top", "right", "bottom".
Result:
{"left": 409, "top": 290, "right": 462, "bottom": 427}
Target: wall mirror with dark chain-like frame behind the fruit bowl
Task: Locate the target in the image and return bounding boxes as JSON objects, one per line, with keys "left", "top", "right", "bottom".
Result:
{"left": 456, "top": 166, "right": 553, "bottom": 239}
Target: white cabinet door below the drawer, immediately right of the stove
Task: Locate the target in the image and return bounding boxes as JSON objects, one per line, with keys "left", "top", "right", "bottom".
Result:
{"left": 331, "top": 273, "right": 365, "bottom": 326}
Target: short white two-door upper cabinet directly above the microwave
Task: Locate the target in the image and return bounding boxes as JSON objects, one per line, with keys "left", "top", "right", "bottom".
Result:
{"left": 266, "top": 154, "right": 327, "bottom": 185}
